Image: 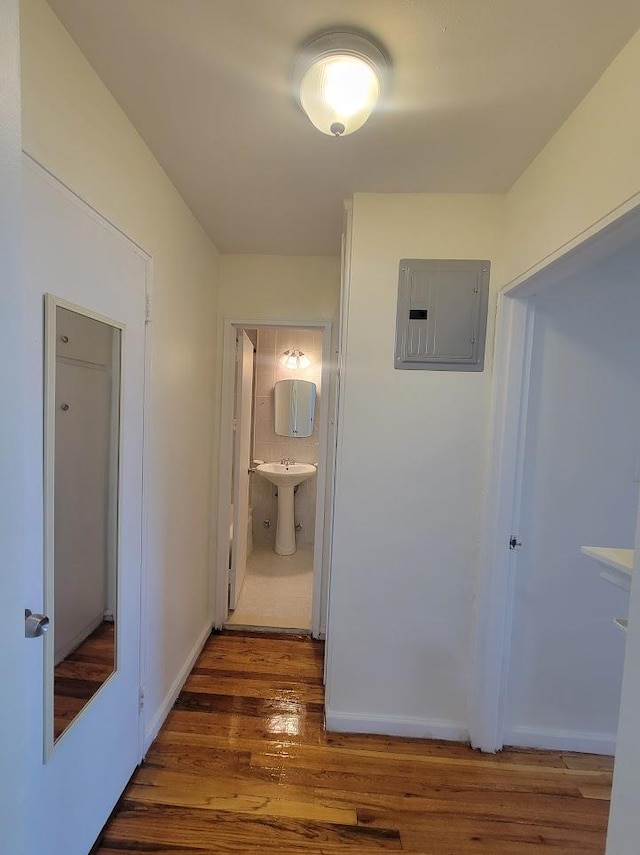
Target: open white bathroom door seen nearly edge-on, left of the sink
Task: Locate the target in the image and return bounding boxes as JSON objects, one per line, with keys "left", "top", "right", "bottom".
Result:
{"left": 229, "top": 330, "right": 253, "bottom": 609}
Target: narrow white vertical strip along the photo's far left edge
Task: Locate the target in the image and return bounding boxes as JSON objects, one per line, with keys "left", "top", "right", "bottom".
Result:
{"left": 0, "top": 13, "right": 28, "bottom": 855}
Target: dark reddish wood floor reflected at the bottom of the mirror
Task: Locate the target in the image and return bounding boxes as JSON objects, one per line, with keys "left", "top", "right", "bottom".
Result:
{"left": 53, "top": 621, "right": 116, "bottom": 740}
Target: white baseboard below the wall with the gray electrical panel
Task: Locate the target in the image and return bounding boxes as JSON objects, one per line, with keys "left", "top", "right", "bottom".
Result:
{"left": 325, "top": 708, "right": 469, "bottom": 742}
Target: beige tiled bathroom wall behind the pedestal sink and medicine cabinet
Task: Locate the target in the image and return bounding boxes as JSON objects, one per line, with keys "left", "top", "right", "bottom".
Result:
{"left": 251, "top": 327, "right": 322, "bottom": 545}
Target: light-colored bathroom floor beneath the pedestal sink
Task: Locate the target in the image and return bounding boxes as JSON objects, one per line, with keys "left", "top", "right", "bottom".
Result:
{"left": 226, "top": 544, "right": 313, "bottom": 632}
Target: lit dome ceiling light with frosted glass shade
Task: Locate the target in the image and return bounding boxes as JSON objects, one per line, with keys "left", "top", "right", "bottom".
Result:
{"left": 293, "top": 30, "right": 389, "bottom": 137}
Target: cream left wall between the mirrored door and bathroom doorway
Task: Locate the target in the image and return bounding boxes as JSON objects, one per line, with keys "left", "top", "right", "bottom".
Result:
{"left": 21, "top": 0, "right": 218, "bottom": 730}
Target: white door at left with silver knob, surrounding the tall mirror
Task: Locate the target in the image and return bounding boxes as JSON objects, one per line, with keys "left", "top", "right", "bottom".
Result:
{"left": 24, "top": 160, "right": 147, "bottom": 855}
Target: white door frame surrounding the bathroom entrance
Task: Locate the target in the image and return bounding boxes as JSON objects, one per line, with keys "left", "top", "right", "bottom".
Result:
{"left": 213, "top": 318, "right": 333, "bottom": 638}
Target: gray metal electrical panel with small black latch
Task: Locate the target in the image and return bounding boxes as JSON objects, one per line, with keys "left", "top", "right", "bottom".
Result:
{"left": 394, "top": 258, "right": 491, "bottom": 371}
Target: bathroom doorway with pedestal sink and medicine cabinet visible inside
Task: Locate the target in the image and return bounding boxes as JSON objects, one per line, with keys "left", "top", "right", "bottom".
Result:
{"left": 214, "top": 321, "right": 336, "bottom": 637}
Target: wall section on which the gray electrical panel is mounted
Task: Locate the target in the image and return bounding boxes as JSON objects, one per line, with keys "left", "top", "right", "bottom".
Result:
{"left": 327, "top": 194, "right": 504, "bottom": 738}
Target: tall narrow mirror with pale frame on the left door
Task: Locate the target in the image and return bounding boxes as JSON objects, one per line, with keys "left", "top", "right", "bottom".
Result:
{"left": 44, "top": 295, "right": 122, "bottom": 756}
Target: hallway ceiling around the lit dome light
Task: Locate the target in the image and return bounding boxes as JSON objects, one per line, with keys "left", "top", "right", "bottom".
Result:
{"left": 50, "top": 0, "right": 640, "bottom": 255}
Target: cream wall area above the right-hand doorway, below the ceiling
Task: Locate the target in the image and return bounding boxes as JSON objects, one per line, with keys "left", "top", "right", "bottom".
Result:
{"left": 504, "top": 32, "right": 640, "bottom": 282}
